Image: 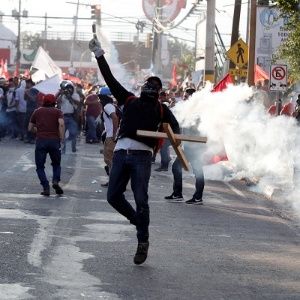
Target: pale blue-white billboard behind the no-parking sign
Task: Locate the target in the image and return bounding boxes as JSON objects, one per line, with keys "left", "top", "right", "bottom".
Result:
{"left": 255, "top": 6, "right": 288, "bottom": 74}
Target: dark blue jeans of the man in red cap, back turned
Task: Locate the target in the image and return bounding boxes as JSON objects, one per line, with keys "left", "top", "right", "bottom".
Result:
{"left": 35, "top": 139, "right": 61, "bottom": 188}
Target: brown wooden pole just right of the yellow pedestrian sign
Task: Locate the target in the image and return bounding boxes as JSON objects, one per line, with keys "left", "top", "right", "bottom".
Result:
{"left": 248, "top": 0, "right": 256, "bottom": 86}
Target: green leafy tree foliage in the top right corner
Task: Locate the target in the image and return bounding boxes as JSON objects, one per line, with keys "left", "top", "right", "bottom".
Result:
{"left": 275, "top": 0, "right": 300, "bottom": 80}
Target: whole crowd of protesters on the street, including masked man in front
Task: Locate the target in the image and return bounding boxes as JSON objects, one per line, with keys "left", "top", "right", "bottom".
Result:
{"left": 0, "top": 36, "right": 300, "bottom": 264}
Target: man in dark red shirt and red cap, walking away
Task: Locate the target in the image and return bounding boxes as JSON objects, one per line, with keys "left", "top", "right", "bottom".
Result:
{"left": 28, "top": 94, "right": 65, "bottom": 196}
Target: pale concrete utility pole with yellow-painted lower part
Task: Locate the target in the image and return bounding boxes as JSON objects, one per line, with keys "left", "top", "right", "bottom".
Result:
{"left": 204, "top": 0, "right": 216, "bottom": 83}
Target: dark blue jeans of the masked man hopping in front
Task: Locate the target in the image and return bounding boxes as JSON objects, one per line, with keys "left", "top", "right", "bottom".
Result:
{"left": 107, "top": 150, "right": 152, "bottom": 243}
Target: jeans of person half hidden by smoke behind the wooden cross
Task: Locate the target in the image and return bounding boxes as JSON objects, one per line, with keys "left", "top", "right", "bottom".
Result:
{"left": 172, "top": 158, "right": 204, "bottom": 199}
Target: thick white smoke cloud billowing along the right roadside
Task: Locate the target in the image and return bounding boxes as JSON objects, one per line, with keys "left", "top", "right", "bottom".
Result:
{"left": 174, "top": 85, "right": 300, "bottom": 217}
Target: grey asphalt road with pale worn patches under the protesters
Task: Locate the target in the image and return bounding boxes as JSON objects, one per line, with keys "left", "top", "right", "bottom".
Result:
{"left": 0, "top": 137, "right": 300, "bottom": 300}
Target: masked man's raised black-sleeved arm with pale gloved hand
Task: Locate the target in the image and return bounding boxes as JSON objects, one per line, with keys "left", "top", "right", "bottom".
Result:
{"left": 89, "top": 35, "right": 133, "bottom": 105}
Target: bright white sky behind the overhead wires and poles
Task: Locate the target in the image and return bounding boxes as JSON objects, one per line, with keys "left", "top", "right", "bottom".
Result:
{"left": 0, "top": 0, "right": 247, "bottom": 46}
